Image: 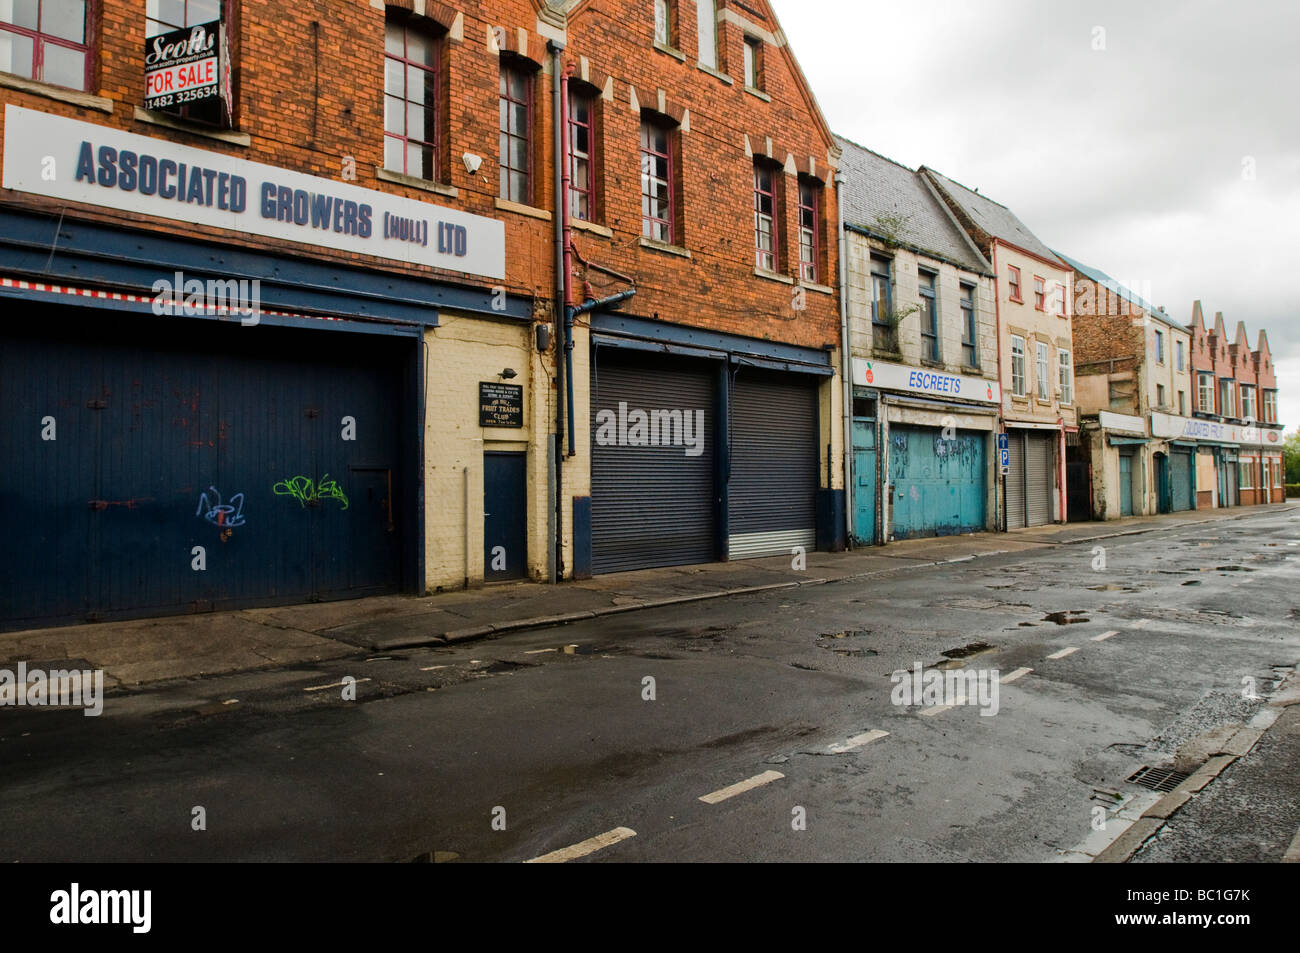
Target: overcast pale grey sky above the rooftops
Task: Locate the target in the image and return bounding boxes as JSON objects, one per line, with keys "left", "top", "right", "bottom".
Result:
{"left": 772, "top": 0, "right": 1300, "bottom": 432}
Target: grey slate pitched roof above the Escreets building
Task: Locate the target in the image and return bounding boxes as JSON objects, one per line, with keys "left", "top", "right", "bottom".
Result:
{"left": 835, "top": 135, "right": 993, "bottom": 274}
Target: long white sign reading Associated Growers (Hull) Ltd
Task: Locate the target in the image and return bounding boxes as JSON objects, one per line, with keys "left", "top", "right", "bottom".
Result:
{"left": 4, "top": 105, "right": 506, "bottom": 278}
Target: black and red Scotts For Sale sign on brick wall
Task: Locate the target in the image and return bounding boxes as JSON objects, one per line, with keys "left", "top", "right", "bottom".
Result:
{"left": 144, "top": 20, "right": 230, "bottom": 118}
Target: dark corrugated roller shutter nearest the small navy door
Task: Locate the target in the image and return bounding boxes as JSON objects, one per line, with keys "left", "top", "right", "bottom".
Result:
{"left": 592, "top": 348, "right": 716, "bottom": 572}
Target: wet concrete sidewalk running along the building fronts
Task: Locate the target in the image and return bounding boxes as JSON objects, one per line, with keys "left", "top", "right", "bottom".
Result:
{"left": 0, "top": 502, "right": 1300, "bottom": 686}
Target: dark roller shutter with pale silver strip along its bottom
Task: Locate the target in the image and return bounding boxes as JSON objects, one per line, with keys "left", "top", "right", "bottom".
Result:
{"left": 727, "top": 368, "right": 818, "bottom": 559}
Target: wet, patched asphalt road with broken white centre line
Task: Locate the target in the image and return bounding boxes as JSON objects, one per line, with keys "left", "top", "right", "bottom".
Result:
{"left": 0, "top": 510, "right": 1300, "bottom": 862}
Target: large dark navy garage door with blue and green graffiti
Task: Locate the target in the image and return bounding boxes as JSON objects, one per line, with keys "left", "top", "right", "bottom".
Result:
{"left": 0, "top": 307, "right": 411, "bottom": 628}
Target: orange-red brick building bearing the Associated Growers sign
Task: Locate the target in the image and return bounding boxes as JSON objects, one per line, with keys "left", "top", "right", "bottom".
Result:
{"left": 0, "top": 0, "right": 842, "bottom": 625}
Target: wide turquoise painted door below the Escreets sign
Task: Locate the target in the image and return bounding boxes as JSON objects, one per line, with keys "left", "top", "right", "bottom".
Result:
{"left": 889, "top": 425, "right": 987, "bottom": 540}
